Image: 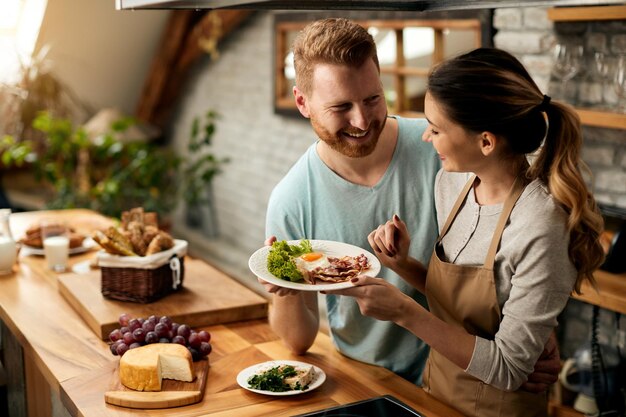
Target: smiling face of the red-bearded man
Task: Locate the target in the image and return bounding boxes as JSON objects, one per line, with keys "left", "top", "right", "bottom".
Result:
{"left": 296, "top": 60, "right": 387, "bottom": 158}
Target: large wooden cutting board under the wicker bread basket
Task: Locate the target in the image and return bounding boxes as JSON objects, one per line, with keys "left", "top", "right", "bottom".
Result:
{"left": 58, "top": 256, "right": 268, "bottom": 340}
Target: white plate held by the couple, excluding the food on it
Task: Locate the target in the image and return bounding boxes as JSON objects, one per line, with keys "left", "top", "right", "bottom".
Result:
{"left": 248, "top": 240, "right": 380, "bottom": 291}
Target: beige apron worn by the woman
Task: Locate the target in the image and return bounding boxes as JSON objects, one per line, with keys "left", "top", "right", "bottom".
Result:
{"left": 424, "top": 176, "right": 548, "bottom": 417}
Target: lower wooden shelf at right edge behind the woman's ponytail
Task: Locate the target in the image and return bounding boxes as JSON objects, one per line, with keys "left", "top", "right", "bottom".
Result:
{"left": 572, "top": 270, "right": 626, "bottom": 314}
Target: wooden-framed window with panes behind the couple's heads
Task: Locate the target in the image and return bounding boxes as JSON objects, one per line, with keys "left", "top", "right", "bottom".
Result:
{"left": 274, "top": 10, "right": 492, "bottom": 116}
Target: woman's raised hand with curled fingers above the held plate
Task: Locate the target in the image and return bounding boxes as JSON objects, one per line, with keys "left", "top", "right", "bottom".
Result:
{"left": 367, "top": 214, "right": 411, "bottom": 270}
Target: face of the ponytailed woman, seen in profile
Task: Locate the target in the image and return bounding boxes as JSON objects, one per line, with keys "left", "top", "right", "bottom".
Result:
{"left": 422, "top": 92, "right": 484, "bottom": 172}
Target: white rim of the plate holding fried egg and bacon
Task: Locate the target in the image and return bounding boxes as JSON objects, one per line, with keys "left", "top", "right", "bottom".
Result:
{"left": 248, "top": 239, "right": 381, "bottom": 291}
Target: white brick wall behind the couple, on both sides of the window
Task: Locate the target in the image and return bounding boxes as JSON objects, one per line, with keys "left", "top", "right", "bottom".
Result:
{"left": 166, "top": 8, "right": 626, "bottom": 287}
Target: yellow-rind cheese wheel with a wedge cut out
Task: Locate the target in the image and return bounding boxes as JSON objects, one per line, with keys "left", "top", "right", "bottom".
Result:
{"left": 120, "top": 343, "right": 195, "bottom": 391}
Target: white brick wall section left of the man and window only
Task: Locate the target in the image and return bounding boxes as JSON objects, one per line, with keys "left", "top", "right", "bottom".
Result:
{"left": 171, "top": 13, "right": 315, "bottom": 287}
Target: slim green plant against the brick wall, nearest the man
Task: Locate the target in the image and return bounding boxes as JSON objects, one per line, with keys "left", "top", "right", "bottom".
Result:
{"left": 182, "top": 110, "right": 229, "bottom": 232}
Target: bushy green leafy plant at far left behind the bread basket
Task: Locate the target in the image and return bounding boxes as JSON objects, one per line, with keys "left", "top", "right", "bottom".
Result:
{"left": 0, "top": 112, "right": 181, "bottom": 218}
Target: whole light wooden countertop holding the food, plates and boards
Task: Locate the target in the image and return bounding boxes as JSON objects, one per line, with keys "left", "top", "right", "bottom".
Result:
{"left": 0, "top": 210, "right": 460, "bottom": 417}
